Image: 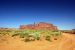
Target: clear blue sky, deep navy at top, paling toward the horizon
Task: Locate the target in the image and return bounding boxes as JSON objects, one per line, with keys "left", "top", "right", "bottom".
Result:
{"left": 0, "top": 0, "right": 75, "bottom": 29}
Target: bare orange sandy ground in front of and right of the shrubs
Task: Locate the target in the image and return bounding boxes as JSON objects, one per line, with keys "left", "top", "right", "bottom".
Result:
{"left": 0, "top": 33, "right": 75, "bottom": 50}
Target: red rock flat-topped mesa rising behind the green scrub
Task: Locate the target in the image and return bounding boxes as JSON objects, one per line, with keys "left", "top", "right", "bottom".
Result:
{"left": 20, "top": 22, "right": 58, "bottom": 30}
